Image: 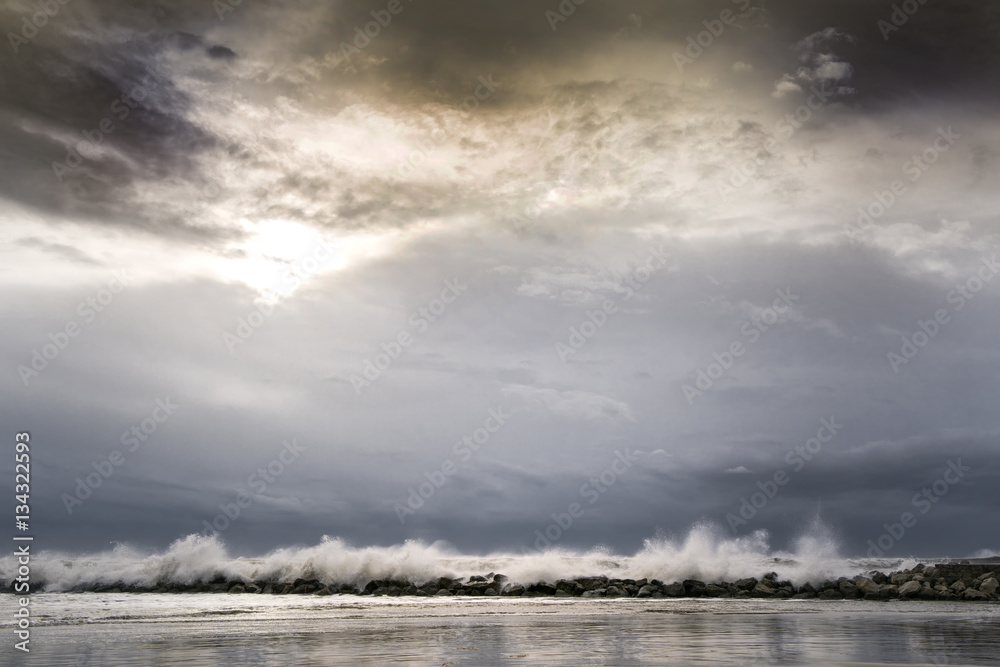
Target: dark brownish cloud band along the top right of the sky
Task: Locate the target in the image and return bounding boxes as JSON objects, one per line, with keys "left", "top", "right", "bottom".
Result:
{"left": 300, "top": 0, "right": 1000, "bottom": 105}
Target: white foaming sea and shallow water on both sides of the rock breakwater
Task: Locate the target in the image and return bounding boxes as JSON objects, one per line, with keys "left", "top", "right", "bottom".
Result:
{"left": 0, "top": 529, "right": 1000, "bottom": 667}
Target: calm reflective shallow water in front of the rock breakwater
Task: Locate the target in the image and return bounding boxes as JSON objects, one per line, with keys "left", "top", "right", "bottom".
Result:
{"left": 0, "top": 593, "right": 1000, "bottom": 667}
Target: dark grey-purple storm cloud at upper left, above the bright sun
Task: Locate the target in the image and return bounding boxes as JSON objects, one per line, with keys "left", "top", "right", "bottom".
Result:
{"left": 0, "top": 14, "right": 223, "bottom": 236}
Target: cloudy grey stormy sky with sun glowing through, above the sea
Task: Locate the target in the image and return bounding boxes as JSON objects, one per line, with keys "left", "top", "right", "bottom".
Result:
{"left": 0, "top": 0, "right": 1000, "bottom": 556}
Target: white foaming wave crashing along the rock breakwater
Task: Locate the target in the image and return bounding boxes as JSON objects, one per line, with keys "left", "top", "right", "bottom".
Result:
{"left": 0, "top": 521, "right": 964, "bottom": 591}
